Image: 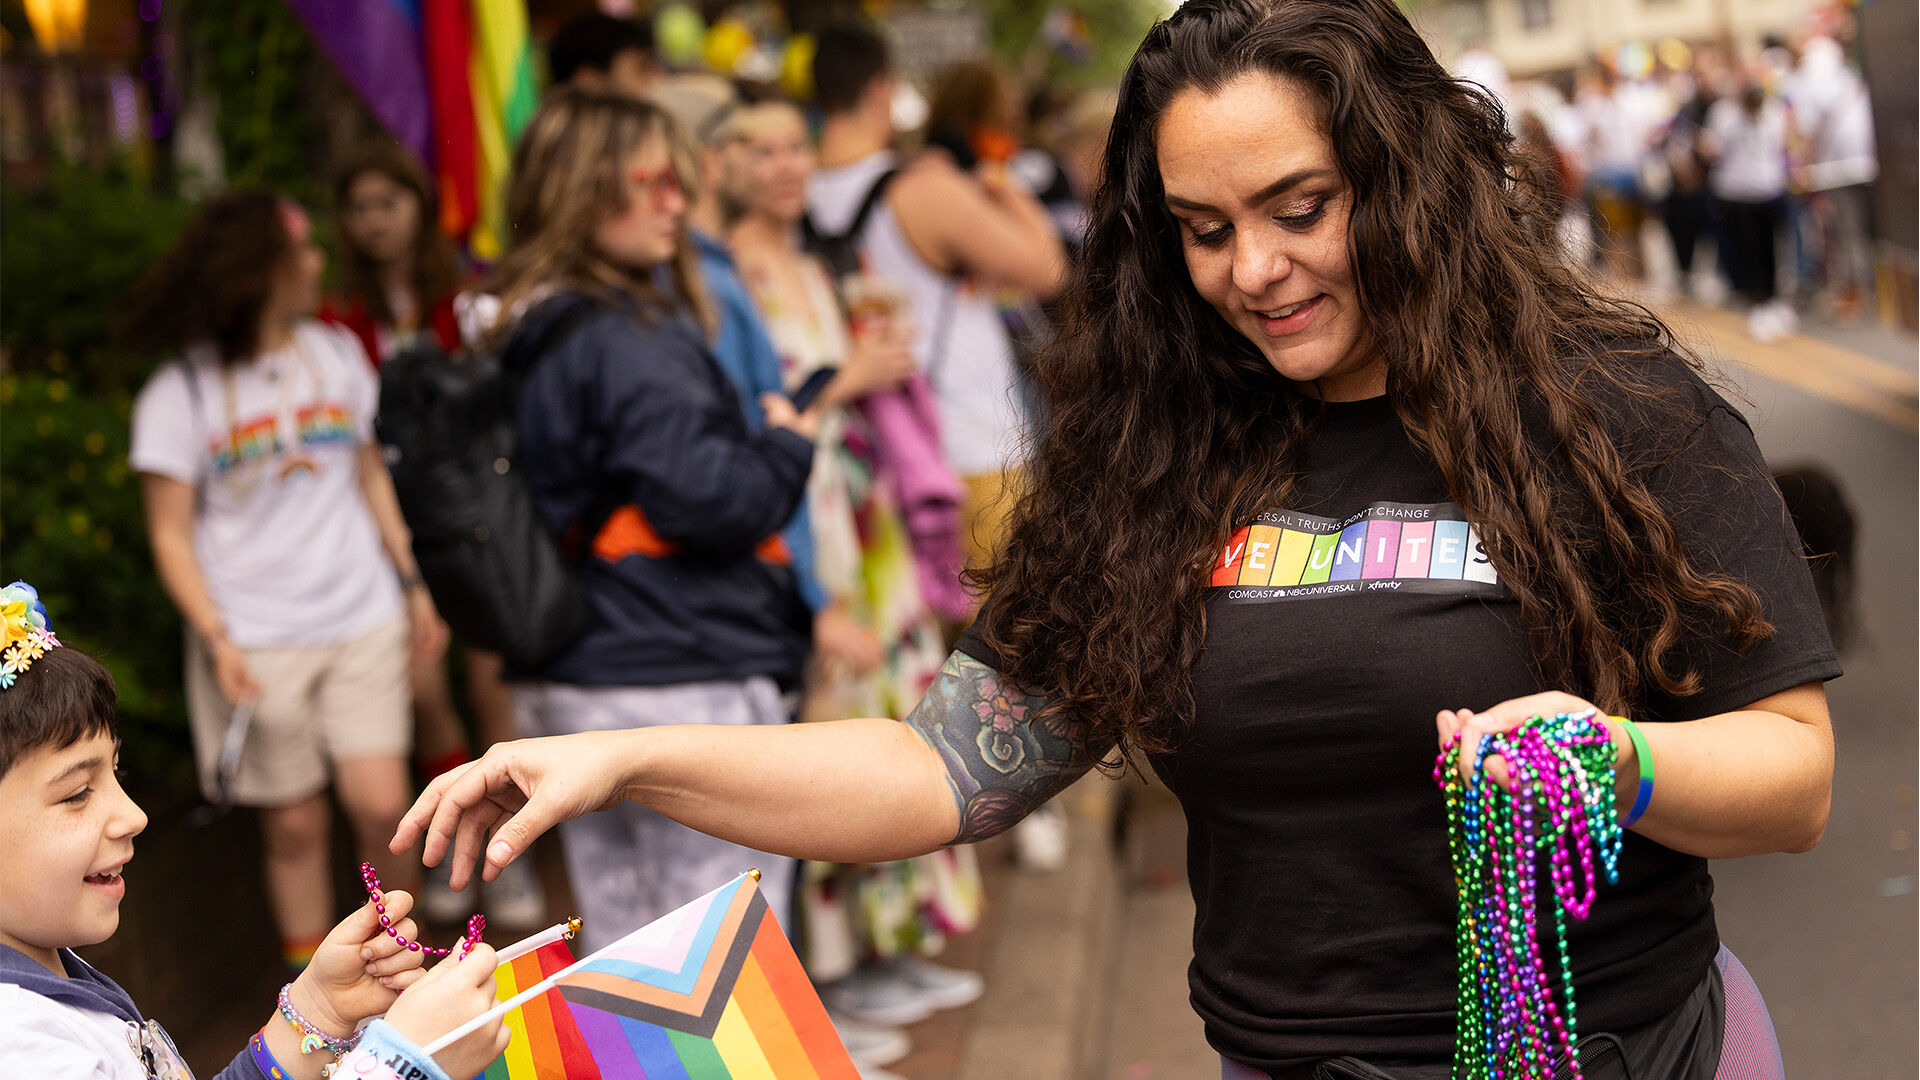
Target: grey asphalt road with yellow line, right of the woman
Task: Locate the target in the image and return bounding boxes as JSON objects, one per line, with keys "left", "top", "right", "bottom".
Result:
{"left": 1688, "top": 295, "right": 1920, "bottom": 1080}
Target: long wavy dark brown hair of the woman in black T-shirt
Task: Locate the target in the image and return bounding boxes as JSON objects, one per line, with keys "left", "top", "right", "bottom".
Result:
{"left": 975, "top": 0, "right": 1770, "bottom": 757}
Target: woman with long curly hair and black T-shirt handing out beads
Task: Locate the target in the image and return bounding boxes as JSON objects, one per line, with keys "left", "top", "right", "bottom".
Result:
{"left": 396, "top": 0, "right": 1839, "bottom": 1080}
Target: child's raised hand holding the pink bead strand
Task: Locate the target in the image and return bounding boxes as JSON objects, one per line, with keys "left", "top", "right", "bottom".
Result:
{"left": 290, "top": 890, "right": 426, "bottom": 1036}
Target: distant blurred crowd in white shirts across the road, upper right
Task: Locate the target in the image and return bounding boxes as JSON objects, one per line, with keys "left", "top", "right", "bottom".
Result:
{"left": 1455, "top": 27, "right": 1880, "bottom": 342}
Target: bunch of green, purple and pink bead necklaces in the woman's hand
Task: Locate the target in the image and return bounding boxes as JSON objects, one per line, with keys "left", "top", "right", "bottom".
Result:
{"left": 1434, "top": 711, "right": 1624, "bottom": 1080}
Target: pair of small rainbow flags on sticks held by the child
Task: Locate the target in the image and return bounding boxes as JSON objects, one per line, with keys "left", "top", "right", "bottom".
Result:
{"left": 468, "top": 874, "right": 860, "bottom": 1080}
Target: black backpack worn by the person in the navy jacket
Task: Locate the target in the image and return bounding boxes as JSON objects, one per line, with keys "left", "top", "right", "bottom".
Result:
{"left": 374, "top": 296, "right": 601, "bottom": 671}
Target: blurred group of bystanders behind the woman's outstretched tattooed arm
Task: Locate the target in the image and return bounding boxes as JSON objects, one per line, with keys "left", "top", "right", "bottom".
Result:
{"left": 108, "top": 13, "right": 1110, "bottom": 1076}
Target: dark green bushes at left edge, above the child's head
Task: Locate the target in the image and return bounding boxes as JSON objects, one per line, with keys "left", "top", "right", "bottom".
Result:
{"left": 0, "top": 167, "right": 192, "bottom": 790}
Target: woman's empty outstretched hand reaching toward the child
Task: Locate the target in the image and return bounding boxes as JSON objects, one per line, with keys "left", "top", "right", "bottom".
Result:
{"left": 390, "top": 730, "right": 639, "bottom": 890}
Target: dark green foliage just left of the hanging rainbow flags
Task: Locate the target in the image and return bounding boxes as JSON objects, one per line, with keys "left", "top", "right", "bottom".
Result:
{"left": 186, "top": 0, "right": 324, "bottom": 206}
